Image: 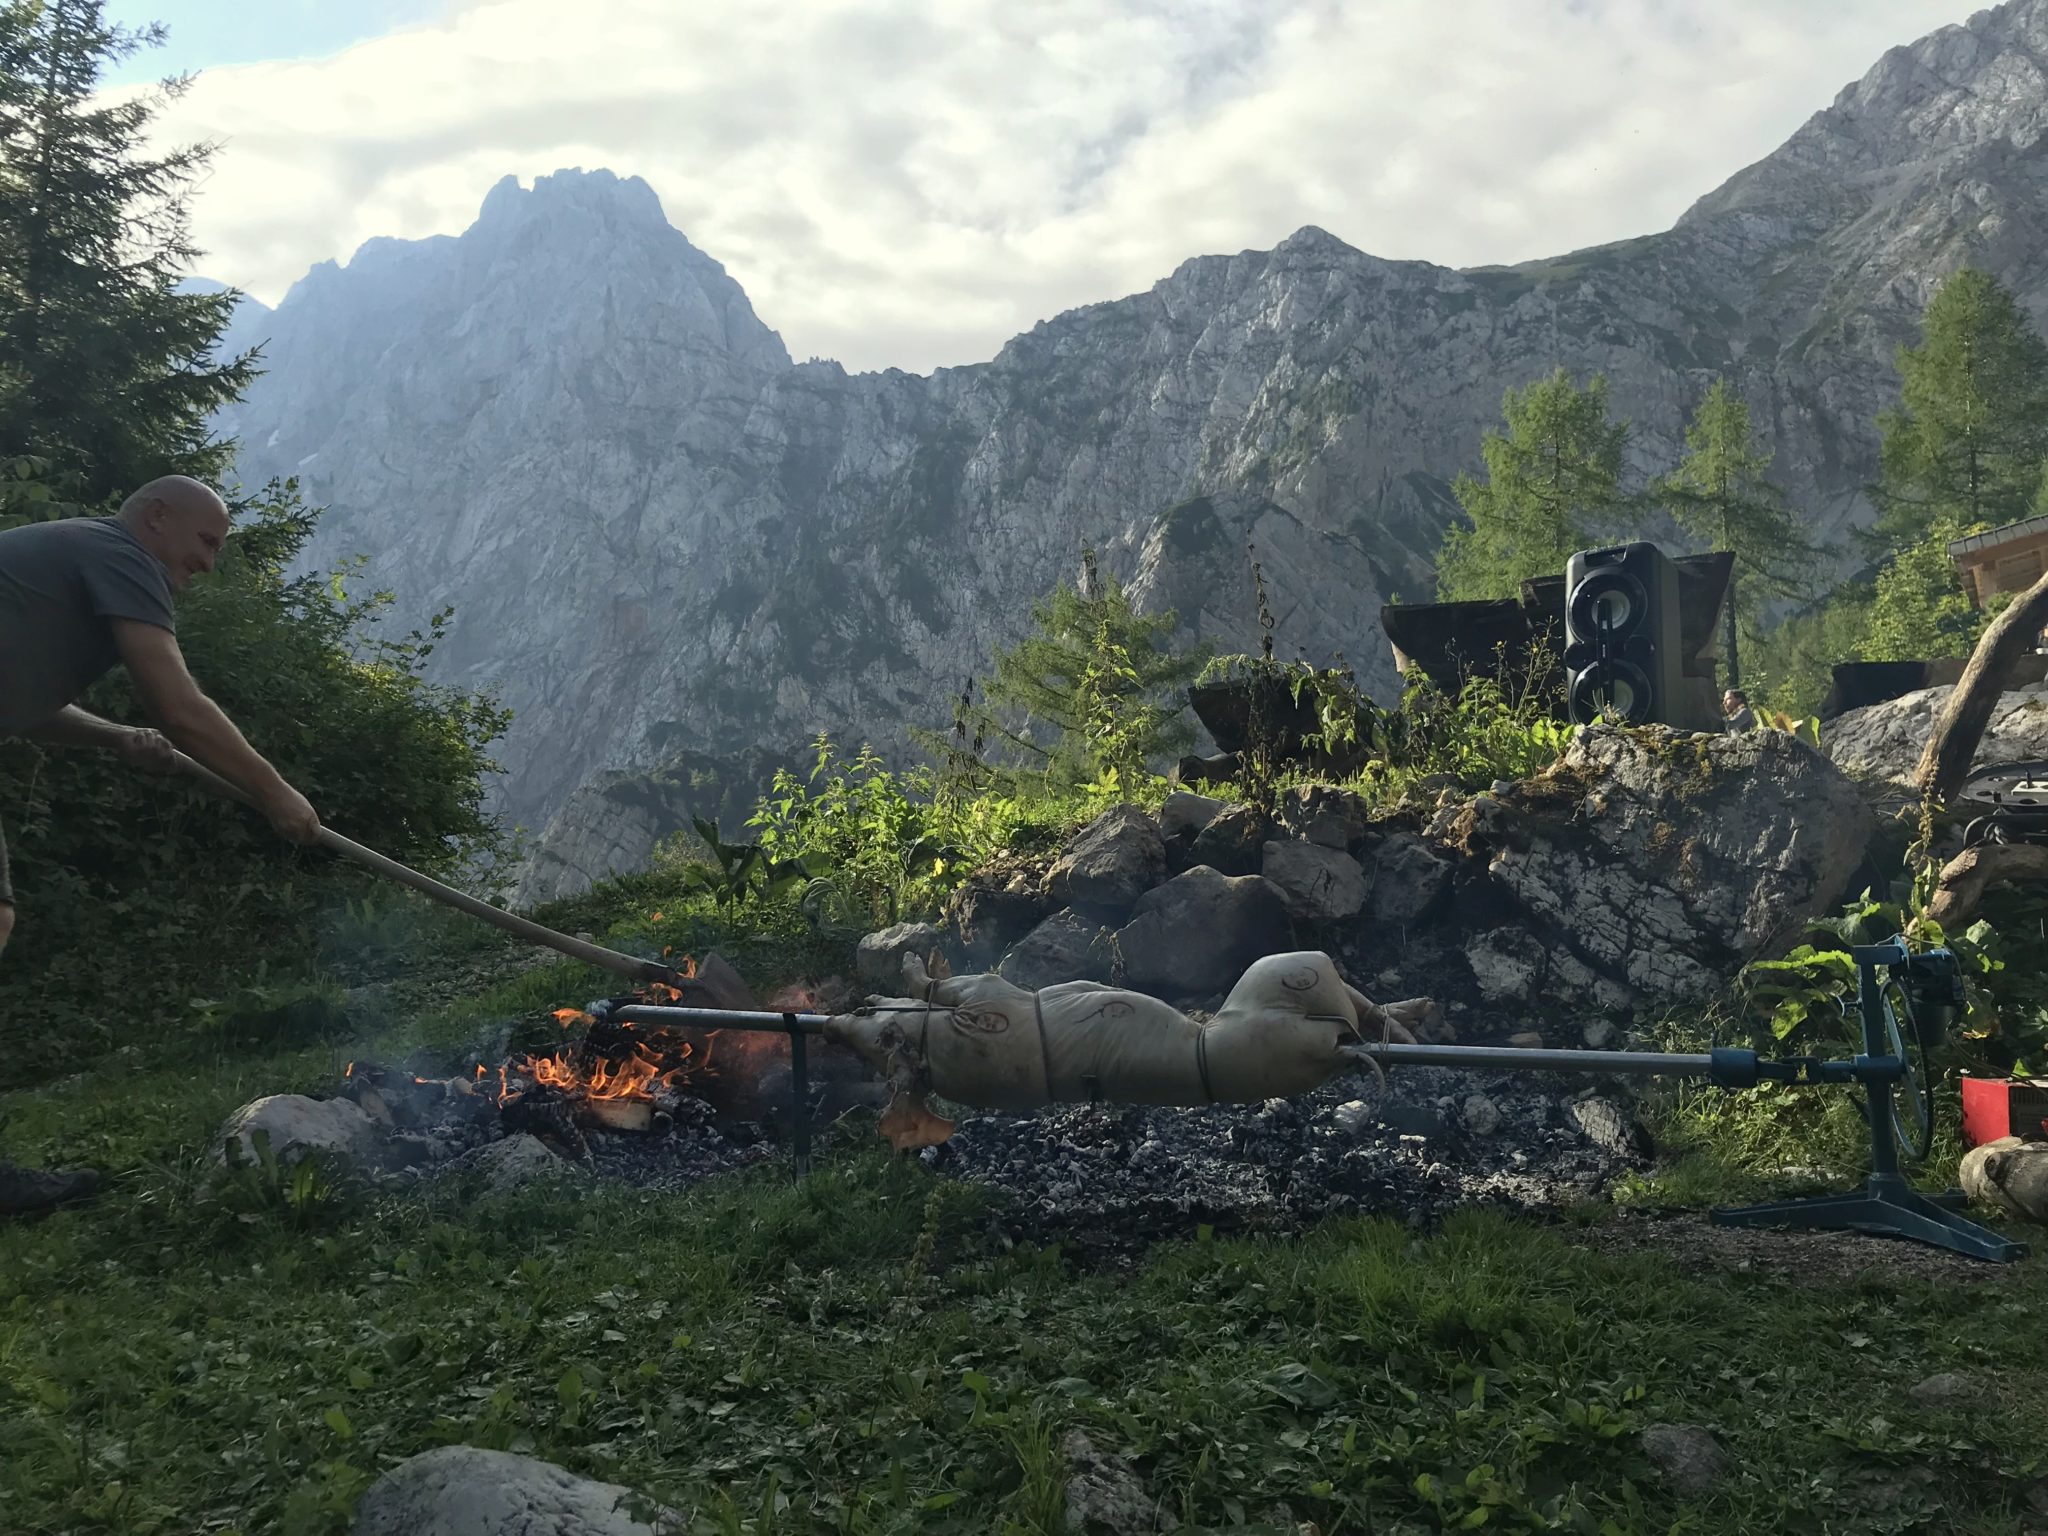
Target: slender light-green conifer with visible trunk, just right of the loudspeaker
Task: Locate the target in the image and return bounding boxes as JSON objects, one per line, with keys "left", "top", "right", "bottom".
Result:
{"left": 1651, "top": 379, "right": 1819, "bottom": 688}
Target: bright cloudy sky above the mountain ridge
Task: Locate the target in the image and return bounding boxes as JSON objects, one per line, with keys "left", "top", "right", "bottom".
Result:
{"left": 106, "top": 0, "right": 1980, "bottom": 373}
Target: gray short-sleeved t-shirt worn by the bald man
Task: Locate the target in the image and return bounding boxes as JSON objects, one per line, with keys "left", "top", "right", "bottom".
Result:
{"left": 0, "top": 518, "right": 176, "bottom": 735}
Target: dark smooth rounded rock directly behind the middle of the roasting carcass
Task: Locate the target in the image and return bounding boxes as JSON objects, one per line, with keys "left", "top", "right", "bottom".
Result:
{"left": 1114, "top": 864, "right": 1294, "bottom": 999}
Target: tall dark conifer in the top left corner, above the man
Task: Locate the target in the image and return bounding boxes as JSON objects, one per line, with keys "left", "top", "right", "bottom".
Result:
{"left": 0, "top": 0, "right": 254, "bottom": 506}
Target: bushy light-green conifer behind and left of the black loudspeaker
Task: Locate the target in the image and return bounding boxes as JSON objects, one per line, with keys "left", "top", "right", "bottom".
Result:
{"left": 1436, "top": 369, "right": 1628, "bottom": 602}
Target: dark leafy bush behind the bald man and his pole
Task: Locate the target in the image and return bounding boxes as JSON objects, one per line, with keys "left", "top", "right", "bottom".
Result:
{"left": 0, "top": 485, "right": 506, "bottom": 1075}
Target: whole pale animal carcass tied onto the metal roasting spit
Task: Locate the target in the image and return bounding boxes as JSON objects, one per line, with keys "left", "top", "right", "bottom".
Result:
{"left": 825, "top": 952, "right": 1436, "bottom": 1151}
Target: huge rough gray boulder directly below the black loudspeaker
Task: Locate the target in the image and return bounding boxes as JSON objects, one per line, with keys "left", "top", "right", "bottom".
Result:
{"left": 1432, "top": 727, "right": 1876, "bottom": 1008}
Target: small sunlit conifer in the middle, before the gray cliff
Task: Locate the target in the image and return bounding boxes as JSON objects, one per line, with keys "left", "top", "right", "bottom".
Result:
{"left": 979, "top": 551, "right": 1208, "bottom": 786}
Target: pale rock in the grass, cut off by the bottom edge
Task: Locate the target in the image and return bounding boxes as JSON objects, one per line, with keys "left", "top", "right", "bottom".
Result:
{"left": 348, "top": 1446, "right": 682, "bottom": 1536}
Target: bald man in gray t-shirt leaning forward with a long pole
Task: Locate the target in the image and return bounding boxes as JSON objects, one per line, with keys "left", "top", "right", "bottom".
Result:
{"left": 0, "top": 475, "right": 319, "bottom": 1217}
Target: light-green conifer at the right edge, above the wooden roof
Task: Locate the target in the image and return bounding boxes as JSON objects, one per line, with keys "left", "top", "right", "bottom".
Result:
{"left": 1876, "top": 268, "right": 2048, "bottom": 551}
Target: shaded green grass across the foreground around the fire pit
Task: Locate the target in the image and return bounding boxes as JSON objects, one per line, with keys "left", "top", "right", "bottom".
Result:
{"left": 0, "top": 884, "right": 2048, "bottom": 1536}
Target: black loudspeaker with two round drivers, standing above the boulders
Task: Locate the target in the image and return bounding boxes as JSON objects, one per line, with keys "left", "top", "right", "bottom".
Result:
{"left": 1565, "top": 543, "right": 1683, "bottom": 725}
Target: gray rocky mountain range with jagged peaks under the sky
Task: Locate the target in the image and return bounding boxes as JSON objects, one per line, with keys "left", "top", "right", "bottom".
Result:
{"left": 221, "top": 0, "right": 2048, "bottom": 899}
